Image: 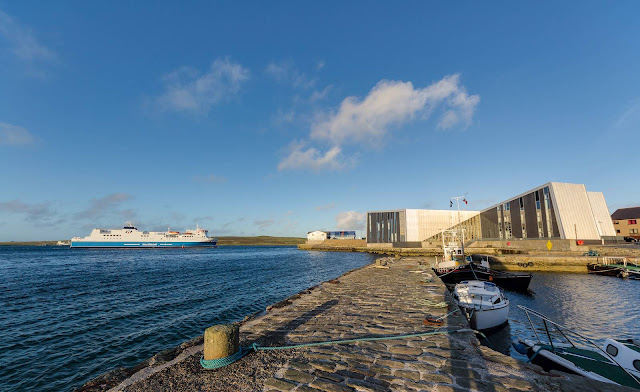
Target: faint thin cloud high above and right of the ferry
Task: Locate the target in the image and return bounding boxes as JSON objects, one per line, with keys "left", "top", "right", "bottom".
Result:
{"left": 156, "top": 58, "right": 250, "bottom": 114}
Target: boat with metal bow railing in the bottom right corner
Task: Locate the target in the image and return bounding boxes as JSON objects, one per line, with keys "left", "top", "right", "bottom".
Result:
{"left": 513, "top": 305, "right": 640, "bottom": 389}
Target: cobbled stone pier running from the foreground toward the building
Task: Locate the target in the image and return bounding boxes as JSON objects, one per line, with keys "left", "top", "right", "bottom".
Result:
{"left": 81, "top": 257, "right": 634, "bottom": 392}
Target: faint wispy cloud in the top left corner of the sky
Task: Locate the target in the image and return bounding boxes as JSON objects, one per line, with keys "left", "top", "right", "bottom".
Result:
{"left": 0, "top": 11, "right": 58, "bottom": 77}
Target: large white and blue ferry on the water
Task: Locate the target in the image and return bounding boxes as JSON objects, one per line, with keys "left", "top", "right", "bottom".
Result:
{"left": 71, "top": 222, "right": 218, "bottom": 248}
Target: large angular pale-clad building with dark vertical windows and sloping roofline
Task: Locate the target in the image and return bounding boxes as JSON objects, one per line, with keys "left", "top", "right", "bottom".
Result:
{"left": 367, "top": 182, "right": 616, "bottom": 247}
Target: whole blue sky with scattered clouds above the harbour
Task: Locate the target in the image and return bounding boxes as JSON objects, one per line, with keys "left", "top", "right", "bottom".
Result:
{"left": 0, "top": 0, "right": 640, "bottom": 241}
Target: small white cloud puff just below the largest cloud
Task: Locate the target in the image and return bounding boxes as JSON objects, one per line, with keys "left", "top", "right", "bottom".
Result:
{"left": 278, "top": 142, "right": 345, "bottom": 171}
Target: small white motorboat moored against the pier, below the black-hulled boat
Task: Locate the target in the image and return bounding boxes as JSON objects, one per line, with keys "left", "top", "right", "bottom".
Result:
{"left": 453, "top": 280, "right": 509, "bottom": 330}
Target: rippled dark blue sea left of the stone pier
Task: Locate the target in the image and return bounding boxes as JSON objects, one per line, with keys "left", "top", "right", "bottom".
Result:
{"left": 0, "top": 246, "right": 374, "bottom": 391}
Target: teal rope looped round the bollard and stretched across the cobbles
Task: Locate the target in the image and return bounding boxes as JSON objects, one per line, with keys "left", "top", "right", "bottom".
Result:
{"left": 200, "top": 328, "right": 473, "bottom": 370}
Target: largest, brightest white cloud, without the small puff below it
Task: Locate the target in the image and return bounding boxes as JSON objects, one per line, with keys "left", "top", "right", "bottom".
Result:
{"left": 311, "top": 74, "right": 480, "bottom": 145}
